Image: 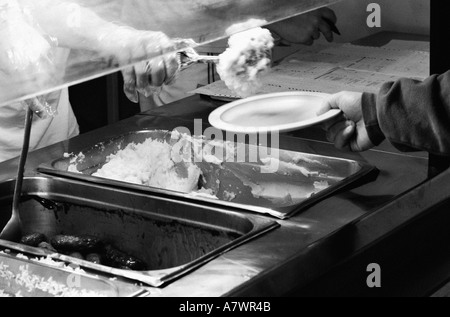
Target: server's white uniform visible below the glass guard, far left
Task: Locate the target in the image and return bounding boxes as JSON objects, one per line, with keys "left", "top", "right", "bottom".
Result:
{"left": 0, "top": 49, "right": 79, "bottom": 161}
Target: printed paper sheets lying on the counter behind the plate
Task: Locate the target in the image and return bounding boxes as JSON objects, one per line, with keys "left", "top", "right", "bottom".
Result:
{"left": 192, "top": 41, "right": 430, "bottom": 100}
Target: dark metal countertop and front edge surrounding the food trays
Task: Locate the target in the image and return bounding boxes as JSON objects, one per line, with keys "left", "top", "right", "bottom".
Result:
{"left": 0, "top": 92, "right": 440, "bottom": 297}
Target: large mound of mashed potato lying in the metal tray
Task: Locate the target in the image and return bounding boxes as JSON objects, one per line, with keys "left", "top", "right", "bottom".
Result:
{"left": 93, "top": 139, "right": 202, "bottom": 193}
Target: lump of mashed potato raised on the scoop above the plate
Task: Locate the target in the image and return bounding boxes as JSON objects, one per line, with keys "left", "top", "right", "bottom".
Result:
{"left": 217, "top": 27, "right": 274, "bottom": 97}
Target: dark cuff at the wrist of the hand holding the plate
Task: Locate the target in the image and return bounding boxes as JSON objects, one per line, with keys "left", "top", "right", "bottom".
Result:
{"left": 361, "top": 93, "right": 386, "bottom": 145}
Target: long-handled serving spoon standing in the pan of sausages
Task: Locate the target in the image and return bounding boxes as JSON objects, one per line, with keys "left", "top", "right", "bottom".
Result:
{"left": 0, "top": 107, "right": 33, "bottom": 242}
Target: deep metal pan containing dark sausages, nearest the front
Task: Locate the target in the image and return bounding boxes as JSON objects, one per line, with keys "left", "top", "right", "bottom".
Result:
{"left": 0, "top": 177, "right": 279, "bottom": 287}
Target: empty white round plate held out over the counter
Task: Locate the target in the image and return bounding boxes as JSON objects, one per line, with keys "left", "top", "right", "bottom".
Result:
{"left": 209, "top": 92, "right": 341, "bottom": 133}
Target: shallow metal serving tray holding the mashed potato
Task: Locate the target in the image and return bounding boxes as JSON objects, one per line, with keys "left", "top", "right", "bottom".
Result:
{"left": 38, "top": 130, "right": 378, "bottom": 219}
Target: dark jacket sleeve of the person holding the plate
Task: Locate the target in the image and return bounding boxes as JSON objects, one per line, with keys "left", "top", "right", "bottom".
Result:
{"left": 362, "top": 71, "right": 450, "bottom": 156}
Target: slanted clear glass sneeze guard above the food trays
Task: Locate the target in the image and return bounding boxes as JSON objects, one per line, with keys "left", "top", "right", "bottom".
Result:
{"left": 0, "top": 0, "right": 338, "bottom": 105}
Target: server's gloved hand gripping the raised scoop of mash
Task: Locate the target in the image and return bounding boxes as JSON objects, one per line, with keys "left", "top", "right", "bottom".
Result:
{"left": 100, "top": 27, "right": 180, "bottom": 103}
